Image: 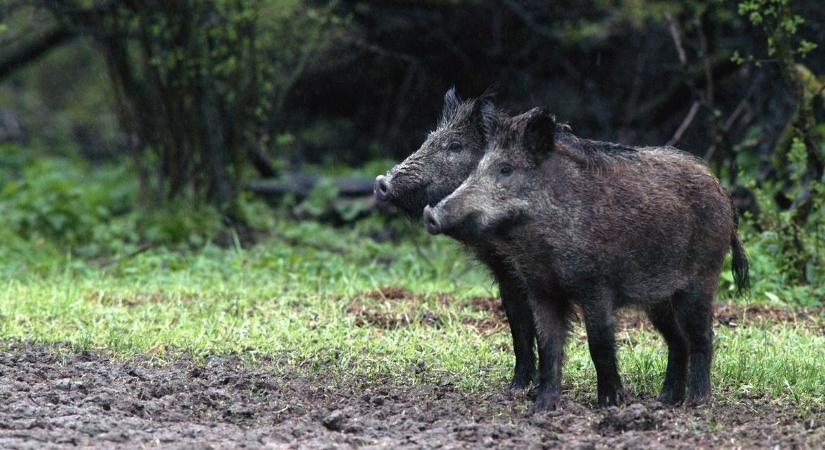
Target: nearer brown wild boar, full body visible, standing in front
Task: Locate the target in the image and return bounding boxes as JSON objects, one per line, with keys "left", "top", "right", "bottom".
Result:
{"left": 424, "top": 108, "right": 748, "bottom": 411}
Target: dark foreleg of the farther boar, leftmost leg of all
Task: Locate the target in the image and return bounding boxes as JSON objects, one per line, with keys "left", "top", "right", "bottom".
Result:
{"left": 495, "top": 270, "right": 536, "bottom": 389}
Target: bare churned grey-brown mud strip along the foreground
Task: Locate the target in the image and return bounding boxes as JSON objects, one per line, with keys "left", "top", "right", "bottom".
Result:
{"left": 0, "top": 343, "right": 825, "bottom": 449}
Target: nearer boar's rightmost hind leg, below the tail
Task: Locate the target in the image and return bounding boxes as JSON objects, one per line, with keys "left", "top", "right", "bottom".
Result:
{"left": 673, "top": 283, "right": 713, "bottom": 405}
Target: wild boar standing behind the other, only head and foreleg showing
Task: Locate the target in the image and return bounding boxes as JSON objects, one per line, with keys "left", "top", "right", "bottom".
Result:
{"left": 375, "top": 89, "right": 536, "bottom": 389}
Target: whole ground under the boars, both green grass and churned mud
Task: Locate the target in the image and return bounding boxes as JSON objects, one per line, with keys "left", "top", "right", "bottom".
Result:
{"left": 0, "top": 223, "right": 825, "bottom": 449}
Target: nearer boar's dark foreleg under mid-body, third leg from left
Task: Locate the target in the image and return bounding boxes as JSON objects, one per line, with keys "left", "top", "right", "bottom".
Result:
{"left": 581, "top": 289, "right": 625, "bottom": 407}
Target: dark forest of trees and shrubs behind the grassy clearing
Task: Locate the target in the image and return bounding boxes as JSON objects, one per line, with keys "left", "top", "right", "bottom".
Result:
{"left": 0, "top": 0, "right": 825, "bottom": 298}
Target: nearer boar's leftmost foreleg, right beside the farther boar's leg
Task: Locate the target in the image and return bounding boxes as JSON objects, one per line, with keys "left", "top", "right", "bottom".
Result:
{"left": 528, "top": 291, "right": 570, "bottom": 413}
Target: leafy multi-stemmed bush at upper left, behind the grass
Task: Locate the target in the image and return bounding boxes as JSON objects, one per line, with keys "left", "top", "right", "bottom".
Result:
{"left": 12, "top": 0, "right": 342, "bottom": 206}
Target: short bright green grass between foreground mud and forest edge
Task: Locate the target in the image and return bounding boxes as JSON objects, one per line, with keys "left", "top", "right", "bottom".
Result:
{"left": 0, "top": 221, "right": 825, "bottom": 405}
